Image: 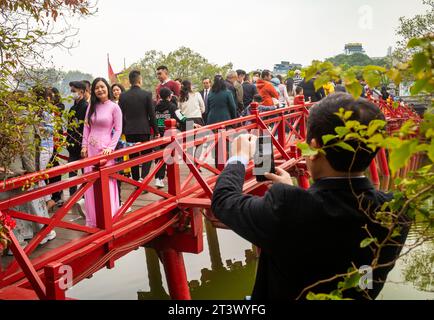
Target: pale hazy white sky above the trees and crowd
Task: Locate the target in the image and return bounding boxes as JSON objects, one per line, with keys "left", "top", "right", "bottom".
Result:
{"left": 53, "top": 0, "right": 426, "bottom": 77}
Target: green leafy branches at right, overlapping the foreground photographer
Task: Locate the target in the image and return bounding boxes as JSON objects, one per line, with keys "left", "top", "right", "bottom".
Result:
{"left": 299, "top": 34, "right": 434, "bottom": 299}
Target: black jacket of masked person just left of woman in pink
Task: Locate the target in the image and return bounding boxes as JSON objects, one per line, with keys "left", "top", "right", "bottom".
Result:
{"left": 66, "top": 98, "right": 88, "bottom": 158}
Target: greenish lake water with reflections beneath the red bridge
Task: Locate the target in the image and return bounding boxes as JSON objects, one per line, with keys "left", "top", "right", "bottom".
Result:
{"left": 67, "top": 218, "right": 434, "bottom": 300}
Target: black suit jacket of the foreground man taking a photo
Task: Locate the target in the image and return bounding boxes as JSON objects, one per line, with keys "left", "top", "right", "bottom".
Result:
{"left": 212, "top": 162, "right": 408, "bottom": 300}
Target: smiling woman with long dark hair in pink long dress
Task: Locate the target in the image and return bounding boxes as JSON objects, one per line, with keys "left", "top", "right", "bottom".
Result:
{"left": 81, "top": 78, "right": 122, "bottom": 227}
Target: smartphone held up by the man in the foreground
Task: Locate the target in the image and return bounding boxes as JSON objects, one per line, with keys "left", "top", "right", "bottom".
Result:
{"left": 253, "top": 135, "right": 276, "bottom": 182}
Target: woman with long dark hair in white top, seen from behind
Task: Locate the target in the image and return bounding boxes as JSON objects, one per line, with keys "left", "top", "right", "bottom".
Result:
{"left": 179, "top": 80, "right": 205, "bottom": 126}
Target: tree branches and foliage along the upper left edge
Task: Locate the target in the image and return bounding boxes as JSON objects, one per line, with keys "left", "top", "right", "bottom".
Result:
{"left": 0, "top": 0, "right": 92, "bottom": 172}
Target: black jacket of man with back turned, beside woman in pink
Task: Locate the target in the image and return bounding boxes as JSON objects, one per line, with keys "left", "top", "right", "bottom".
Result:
{"left": 119, "top": 86, "right": 158, "bottom": 135}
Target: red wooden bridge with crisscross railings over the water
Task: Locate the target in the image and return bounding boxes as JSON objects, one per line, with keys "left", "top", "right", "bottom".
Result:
{"left": 0, "top": 101, "right": 417, "bottom": 299}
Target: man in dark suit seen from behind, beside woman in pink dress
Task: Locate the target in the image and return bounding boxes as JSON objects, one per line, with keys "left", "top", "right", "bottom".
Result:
{"left": 119, "top": 70, "right": 158, "bottom": 181}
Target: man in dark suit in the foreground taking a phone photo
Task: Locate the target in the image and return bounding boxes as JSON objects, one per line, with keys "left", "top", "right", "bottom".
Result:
{"left": 212, "top": 93, "right": 408, "bottom": 300}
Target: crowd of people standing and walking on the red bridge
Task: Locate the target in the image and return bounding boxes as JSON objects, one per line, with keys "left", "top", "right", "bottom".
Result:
{"left": 1, "top": 66, "right": 396, "bottom": 254}
